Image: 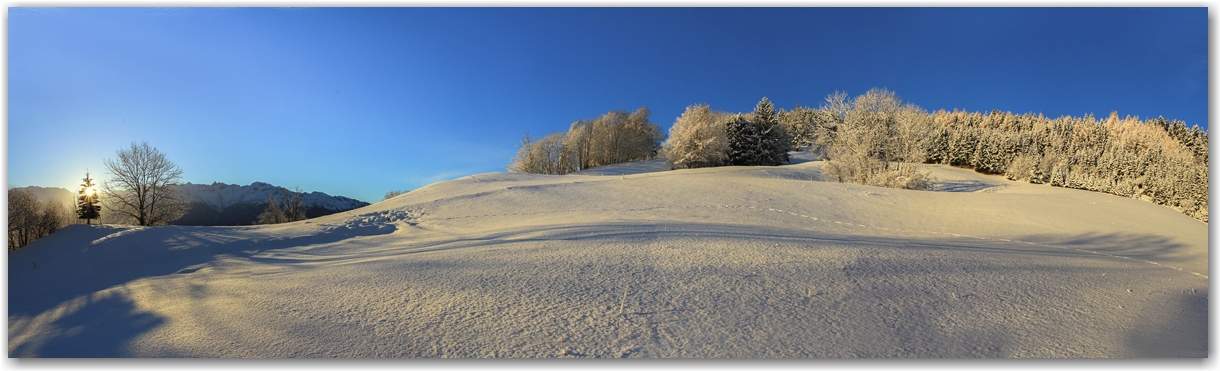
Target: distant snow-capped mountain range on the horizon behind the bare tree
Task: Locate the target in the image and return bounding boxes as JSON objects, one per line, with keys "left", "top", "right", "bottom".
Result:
{"left": 11, "top": 182, "right": 368, "bottom": 226}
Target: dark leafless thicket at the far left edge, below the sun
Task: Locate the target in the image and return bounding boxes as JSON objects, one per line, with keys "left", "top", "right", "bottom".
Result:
{"left": 9, "top": 189, "right": 73, "bottom": 253}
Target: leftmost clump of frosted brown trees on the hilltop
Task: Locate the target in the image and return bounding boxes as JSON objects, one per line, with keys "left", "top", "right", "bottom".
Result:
{"left": 509, "top": 107, "right": 665, "bottom": 175}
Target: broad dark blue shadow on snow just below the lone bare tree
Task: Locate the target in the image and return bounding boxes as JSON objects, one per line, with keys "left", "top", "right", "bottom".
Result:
{"left": 9, "top": 225, "right": 394, "bottom": 322}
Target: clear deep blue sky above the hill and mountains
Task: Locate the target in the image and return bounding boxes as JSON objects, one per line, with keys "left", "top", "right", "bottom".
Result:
{"left": 7, "top": 7, "right": 1208, "bottom": 203}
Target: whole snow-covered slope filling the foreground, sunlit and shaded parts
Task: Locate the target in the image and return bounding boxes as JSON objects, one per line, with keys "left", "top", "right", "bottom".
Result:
{"left": 9, "top": 161, "right": 1209, "bottom": 358}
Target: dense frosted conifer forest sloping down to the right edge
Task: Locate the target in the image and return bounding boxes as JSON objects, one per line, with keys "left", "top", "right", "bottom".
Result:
{"left": 927, "top": 110, "right": 1208, "bottom": 222}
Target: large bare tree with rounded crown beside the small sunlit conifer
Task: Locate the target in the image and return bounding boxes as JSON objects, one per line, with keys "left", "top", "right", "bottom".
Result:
{"left": 101, "top": 142, "right": 187, "bottom": 226}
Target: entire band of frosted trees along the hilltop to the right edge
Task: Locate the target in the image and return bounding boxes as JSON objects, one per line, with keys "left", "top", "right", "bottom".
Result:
{"left": 509, "top": 89, "right": 1208, "bottom": 222}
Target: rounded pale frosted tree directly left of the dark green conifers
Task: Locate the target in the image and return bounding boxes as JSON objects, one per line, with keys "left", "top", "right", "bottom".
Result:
{"left": 662, "top": 104, "right": 728, "bottom": 168}
